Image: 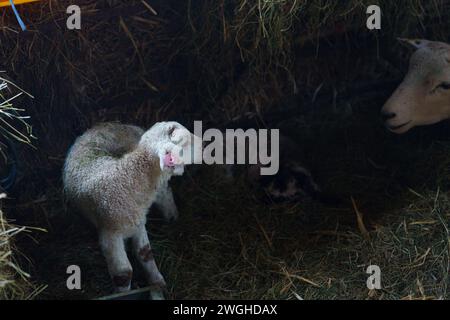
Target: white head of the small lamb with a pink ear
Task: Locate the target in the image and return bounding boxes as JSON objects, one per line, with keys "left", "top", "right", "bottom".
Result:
{"left": 140, "top": 121, "right": 202, "bottom": 175}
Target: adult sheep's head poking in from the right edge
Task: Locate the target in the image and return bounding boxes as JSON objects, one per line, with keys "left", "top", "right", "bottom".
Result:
{"left": 381, "top": 39, "right": 450, "bottom": 134}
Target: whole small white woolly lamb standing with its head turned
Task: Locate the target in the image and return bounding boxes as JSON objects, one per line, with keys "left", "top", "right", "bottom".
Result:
{"left": 63, "top": 122, "right": 201, "bottom": 292}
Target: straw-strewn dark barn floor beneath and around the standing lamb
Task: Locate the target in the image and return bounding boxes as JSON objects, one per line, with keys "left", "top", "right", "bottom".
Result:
{"left": 7, "top": 98, "right": 450, "bottom": 299}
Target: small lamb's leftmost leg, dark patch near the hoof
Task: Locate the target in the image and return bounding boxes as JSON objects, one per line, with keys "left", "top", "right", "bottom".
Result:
{"left": 100, "top": 232, "right": 133, "bottom": 292}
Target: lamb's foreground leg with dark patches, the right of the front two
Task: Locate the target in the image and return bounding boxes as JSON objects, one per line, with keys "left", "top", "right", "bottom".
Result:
{"left": 132, "top": 224, "right": 166, "bottom": 288}
